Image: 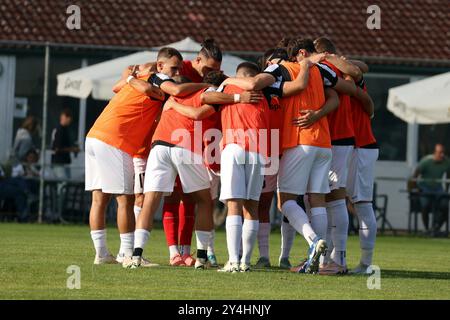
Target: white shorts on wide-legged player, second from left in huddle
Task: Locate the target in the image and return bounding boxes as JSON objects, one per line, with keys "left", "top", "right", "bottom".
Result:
{"left": 144, "top": 145, "right": 210, "bottom": 193}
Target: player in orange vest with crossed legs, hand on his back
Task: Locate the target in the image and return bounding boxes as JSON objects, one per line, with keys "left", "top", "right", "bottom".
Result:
{"left": 221, "top": 39, "right": 338, "bottom": 272}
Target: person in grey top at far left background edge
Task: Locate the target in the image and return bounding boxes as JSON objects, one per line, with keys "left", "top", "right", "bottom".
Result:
{"left": 13, "top": 116, "right": 38, "bottom": 162}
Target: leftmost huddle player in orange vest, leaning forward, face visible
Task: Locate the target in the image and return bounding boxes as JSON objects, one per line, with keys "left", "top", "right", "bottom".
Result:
{"left": 85, "top": 47, "right": 205, "bottom": 264}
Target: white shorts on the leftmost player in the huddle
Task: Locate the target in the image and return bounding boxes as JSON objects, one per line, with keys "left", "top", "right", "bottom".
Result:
{"left": 85, "top": 138, "right": 134, "bottom": 194}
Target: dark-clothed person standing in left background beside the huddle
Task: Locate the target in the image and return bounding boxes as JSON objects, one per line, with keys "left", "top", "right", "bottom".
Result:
{"left": 52, "top": 108, "right": 80, "bottom": 179}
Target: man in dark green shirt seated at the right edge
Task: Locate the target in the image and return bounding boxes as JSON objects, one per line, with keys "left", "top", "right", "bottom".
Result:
{"left": 412, "top": 143, "right": 450, "bottom": 231}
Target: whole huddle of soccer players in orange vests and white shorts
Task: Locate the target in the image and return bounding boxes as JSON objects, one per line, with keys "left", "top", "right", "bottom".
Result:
{"left": 85, "top": 37, "right": 378, "bottom": 275}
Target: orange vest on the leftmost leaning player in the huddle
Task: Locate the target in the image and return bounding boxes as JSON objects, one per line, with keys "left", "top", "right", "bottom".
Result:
{"left": 87, "top": 76, "right": 162, "bottom": 156}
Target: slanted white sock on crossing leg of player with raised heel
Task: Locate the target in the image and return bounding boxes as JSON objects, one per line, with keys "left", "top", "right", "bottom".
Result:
{"left": 281, "top": 200, "right": 317, "bottom": 245}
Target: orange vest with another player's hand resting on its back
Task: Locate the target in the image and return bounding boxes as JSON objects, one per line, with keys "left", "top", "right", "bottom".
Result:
{"left": 281, "top": 62, "right": 331, "bottom": 150}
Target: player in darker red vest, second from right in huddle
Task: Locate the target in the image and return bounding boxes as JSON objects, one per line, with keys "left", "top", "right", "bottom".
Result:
{"left": 314, "top": 37, "right": 372, "bottom": 275}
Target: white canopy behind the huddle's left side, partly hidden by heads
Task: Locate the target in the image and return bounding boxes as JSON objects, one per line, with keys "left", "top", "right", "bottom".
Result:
{"left": 57, "top": 38, "right": 244, "bottom": 100}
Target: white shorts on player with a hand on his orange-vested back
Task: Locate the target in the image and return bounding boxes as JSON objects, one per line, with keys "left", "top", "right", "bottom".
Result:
{"left": 278, "top": 145, "right": 331, "bottom": 195}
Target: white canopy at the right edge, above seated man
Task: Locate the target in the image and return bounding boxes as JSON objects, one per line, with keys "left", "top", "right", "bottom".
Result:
{"left": 387, "top": 72, "right": 450, "bottom": 124}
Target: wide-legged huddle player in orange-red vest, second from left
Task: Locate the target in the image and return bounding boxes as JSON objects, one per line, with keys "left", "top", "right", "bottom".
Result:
{"left": 123, "top": 73, "right": 229, "bottom": 268}
